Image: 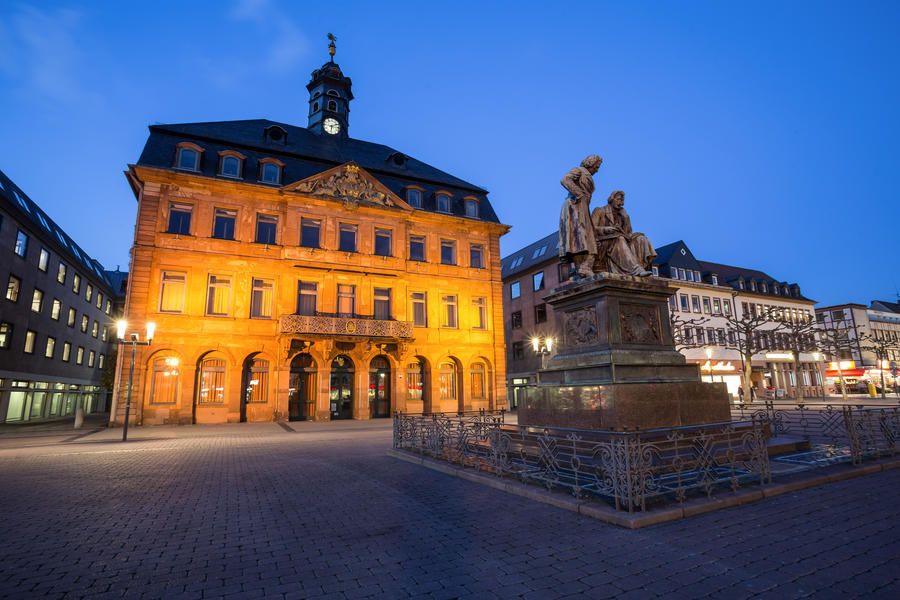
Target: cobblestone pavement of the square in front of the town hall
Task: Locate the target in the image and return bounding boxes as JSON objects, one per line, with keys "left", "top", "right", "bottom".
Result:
{"left": 0, "top": 421, "right": 900, "bottom": 599}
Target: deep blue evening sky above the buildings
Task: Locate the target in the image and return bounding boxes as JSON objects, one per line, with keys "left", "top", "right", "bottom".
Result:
{"left": 0, "top": 0, "right": 900, "bottom": 304}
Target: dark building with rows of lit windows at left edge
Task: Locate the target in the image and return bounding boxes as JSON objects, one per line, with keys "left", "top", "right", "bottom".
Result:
{"left": 0, "top": 172, "right": 116, "bottom": 423}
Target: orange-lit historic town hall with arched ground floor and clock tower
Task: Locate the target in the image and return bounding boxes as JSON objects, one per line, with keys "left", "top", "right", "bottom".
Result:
{"left": 112, "top": 51, "right": 508, "bottom": 424}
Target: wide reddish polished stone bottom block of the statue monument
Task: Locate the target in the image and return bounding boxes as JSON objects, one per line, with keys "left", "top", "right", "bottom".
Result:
{"left": 518, "top": 381, "right": 731, "bottom": 431}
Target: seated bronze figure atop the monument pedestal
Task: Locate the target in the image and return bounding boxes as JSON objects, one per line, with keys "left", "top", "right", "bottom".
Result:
{"left": 591, "top": 191, "right": 656, "bottom": 277}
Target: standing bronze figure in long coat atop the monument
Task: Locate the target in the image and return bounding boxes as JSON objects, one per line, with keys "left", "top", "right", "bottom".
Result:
{"left": 559, "top": 154, "right": 603, "bottom": 277}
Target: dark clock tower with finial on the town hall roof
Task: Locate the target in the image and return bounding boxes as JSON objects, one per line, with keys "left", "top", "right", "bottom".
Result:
{"left": 306, "top": 33, "right": 353, "bottom": 139}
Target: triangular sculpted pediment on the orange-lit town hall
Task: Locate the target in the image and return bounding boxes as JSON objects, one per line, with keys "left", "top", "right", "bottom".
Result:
{"left": 283, "top": 162, "right": 411, "bottom": 209}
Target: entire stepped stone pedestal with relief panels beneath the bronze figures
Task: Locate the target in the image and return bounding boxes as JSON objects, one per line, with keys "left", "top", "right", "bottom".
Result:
{"left": 518, "top": 273, "right": 731, "bottom": 430}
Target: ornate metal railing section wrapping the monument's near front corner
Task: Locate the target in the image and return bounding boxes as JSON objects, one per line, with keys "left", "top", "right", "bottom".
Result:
{"left": 394, "top": 413, "right": 771, "bottom": 512}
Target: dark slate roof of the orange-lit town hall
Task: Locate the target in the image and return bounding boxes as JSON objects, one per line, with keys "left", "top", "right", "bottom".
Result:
{"left": 138, "top": 119, "right": 499, "bottom": 223}
